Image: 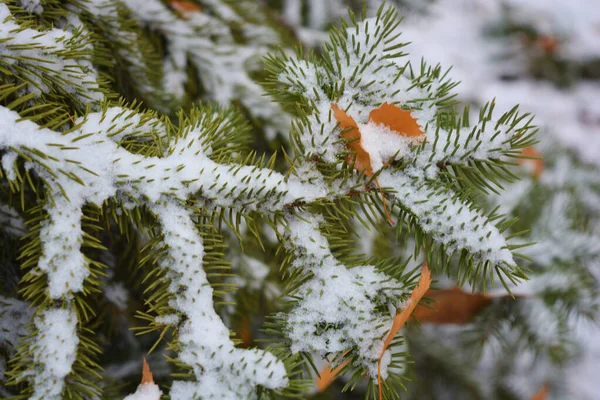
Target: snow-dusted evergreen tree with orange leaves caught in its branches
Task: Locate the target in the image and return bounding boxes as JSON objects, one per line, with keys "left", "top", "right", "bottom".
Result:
{"left": 0, "top": 0, "right": 600, "bottom": 400}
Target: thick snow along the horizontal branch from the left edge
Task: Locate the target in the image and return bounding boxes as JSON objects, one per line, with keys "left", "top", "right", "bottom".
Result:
{"left": 0, "top": 107, "right": 327, "bottom": 219}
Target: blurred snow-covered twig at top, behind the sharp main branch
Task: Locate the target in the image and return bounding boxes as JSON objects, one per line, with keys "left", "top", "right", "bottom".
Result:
{"left": 112, "top": 0, "right": 290, "bottom": 132}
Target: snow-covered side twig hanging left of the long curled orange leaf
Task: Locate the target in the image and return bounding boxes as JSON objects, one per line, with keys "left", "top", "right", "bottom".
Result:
{"left": 279, "top": 213, "right": 404, "bottom": 380}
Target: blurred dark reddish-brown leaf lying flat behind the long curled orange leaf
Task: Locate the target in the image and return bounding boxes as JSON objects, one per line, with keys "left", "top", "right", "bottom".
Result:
{"left": 413, "top": 287, "right": 493, "bottom": 324}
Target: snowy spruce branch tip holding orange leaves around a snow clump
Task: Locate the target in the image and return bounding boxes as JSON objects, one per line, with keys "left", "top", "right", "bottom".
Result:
{"left": 269, "top": 9, "right": 535, "bottom": 288}
